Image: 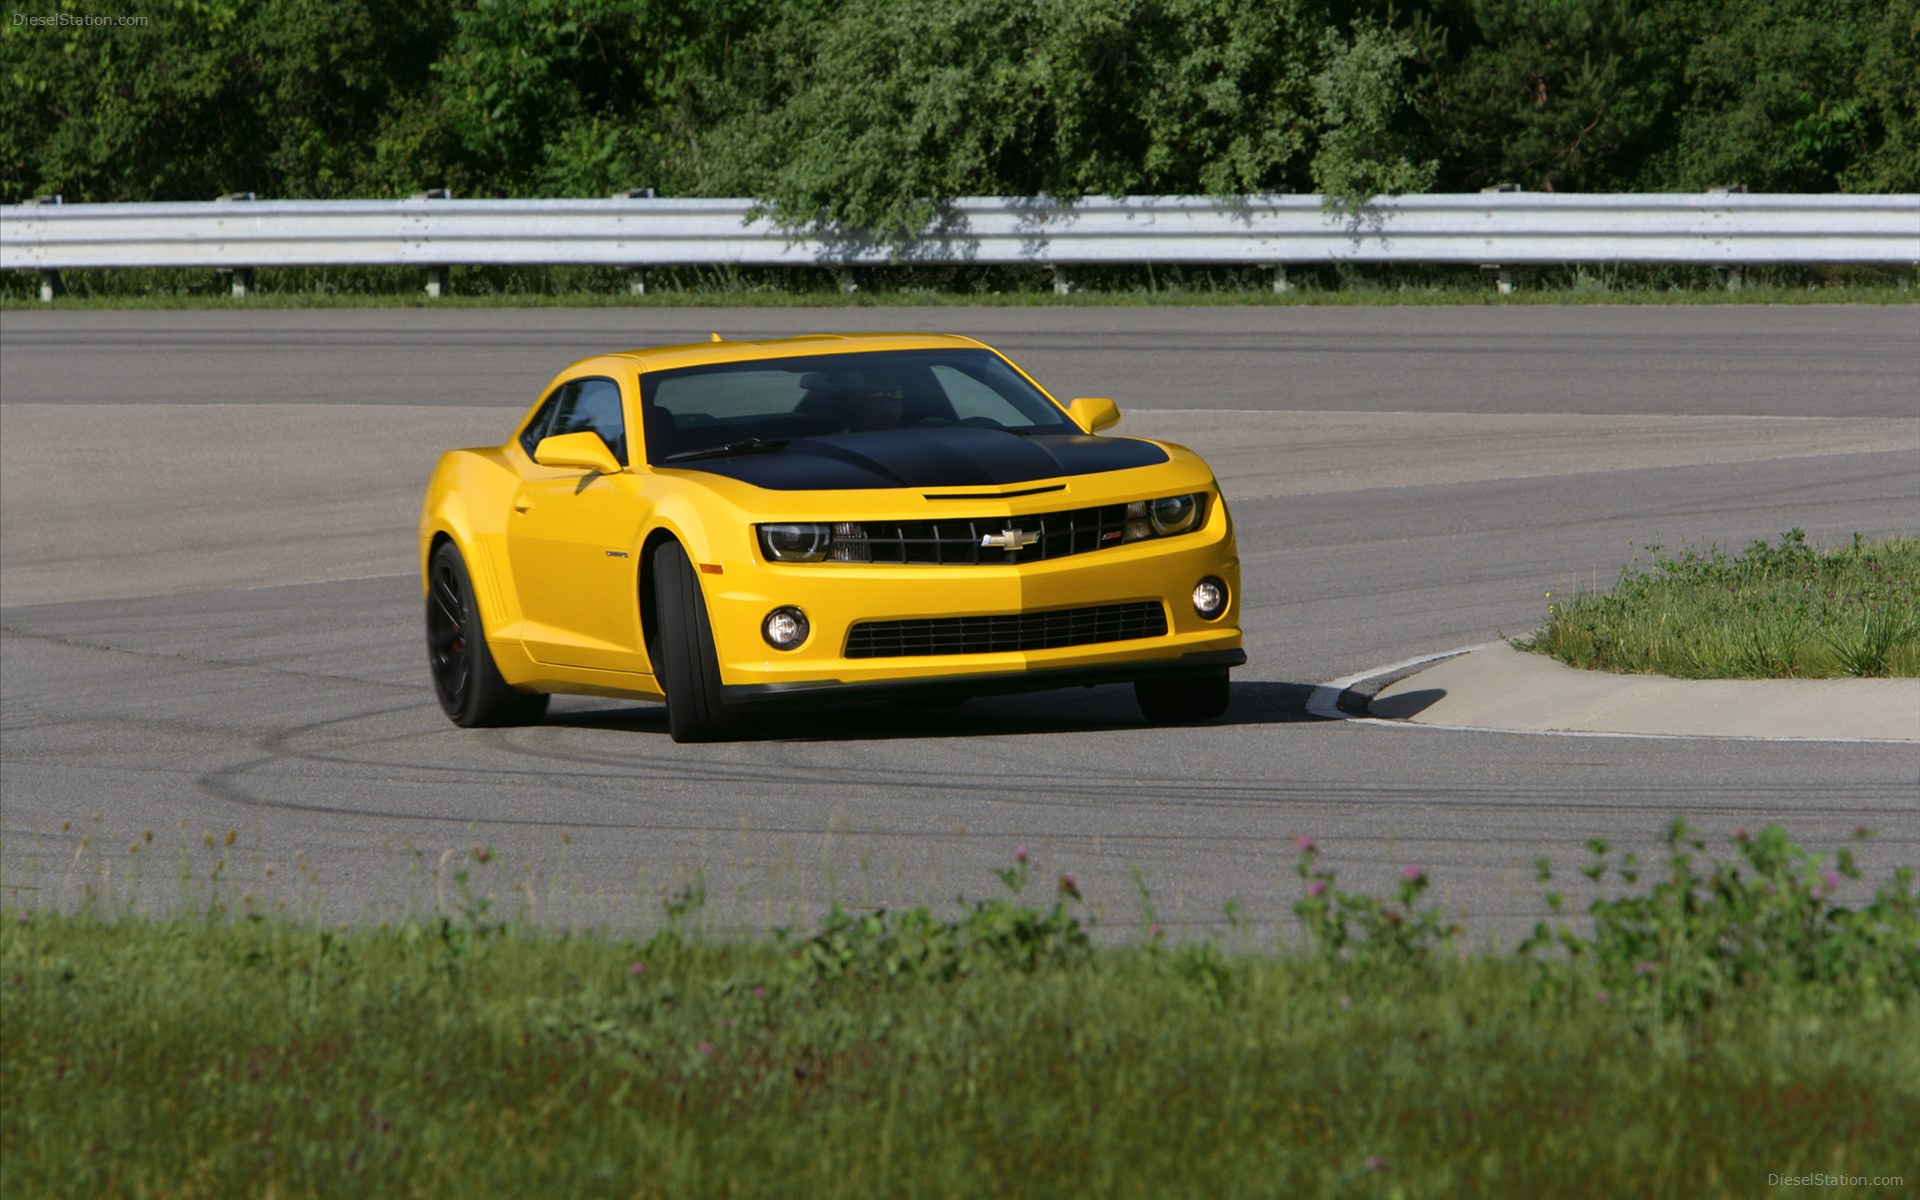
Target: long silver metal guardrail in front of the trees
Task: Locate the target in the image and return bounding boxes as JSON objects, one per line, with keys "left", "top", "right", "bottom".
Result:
{"left": 0, "top": 192, "right": 1920, "bottom": 298}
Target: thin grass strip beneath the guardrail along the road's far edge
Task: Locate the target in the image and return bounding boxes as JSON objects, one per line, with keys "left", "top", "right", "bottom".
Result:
{"left": 0, "top": 263, "right": 1920, "bottom": 311}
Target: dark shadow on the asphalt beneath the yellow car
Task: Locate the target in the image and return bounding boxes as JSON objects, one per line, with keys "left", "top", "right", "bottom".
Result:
{"left": 543, "top": 680, "right": 1323, "bottom": 741}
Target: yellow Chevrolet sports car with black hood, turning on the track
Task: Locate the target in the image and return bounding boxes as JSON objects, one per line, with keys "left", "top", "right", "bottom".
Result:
{"left": 420, "top": 334, "right": 1246, "bottom": 741}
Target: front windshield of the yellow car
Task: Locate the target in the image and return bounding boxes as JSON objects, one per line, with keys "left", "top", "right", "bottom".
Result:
{"left": 639, "top": 349, "right": 1079, "bottom": 463}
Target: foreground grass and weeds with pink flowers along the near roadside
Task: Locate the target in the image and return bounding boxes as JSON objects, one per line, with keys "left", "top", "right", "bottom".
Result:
{"left": 0, "top": 820, "right": 1920, "bottom": 1198}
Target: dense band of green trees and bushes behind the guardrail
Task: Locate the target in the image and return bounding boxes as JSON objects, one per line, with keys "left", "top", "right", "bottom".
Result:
{"left": 0, "top": 0, "right": 1920, "bottom": 232}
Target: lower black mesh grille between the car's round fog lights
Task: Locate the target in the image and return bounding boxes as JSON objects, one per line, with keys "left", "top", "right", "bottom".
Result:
{"left": 847, "top": 601, "right": 1167, "bottom": 659}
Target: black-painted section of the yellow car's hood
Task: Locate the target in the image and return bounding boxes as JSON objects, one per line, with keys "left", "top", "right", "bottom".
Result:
{"left": 672, "top": 428, "right": 1167, "bottom": 492}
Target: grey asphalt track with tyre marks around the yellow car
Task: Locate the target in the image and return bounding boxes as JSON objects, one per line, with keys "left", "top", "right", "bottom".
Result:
{"left": 0, "top": 307, "right": 1920, "bottom": 937}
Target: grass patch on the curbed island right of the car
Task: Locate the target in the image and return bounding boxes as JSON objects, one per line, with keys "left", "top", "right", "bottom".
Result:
{"left": 1515, "top": 530, "right": 1920, "bottom": 680}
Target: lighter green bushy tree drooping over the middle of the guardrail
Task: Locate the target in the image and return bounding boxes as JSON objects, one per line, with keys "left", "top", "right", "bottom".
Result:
{"left": 705, "top": 0, "right": 1427, "bottom": 240}
